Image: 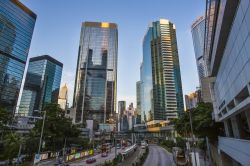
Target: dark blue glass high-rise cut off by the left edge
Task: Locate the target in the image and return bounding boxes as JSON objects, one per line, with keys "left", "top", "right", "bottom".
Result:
{"left": 0, "top": 0, "right": 36, "bottom": 112}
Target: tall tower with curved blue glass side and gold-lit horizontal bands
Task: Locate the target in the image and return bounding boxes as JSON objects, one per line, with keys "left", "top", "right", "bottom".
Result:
{"left": 140, "top": 19, "right": 184, "bottom": 121}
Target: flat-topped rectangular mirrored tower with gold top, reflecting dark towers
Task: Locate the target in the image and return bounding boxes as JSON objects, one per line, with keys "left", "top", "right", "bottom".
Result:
{"left": 73, "top": 22, "right": 118, "bottom": 123}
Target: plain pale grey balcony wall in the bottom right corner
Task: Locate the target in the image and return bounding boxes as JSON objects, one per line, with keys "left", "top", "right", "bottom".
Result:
{"left": 219, "top": 137, "right": 250, "bottom": 165}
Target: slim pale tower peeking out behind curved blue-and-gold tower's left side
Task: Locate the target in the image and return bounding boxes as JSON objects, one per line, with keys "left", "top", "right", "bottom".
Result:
{"left": 136, "top": 81, "right": 141, "bottom": 124}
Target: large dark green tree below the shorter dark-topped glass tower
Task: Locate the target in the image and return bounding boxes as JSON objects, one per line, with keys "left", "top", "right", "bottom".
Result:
{"left": 28, "top": 104, "right": 80, "bottom": 153}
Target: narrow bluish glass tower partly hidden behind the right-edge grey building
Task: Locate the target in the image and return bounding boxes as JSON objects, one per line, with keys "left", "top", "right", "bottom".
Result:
{"left": 191, "top": 16, "right": 207, "bottom": 83}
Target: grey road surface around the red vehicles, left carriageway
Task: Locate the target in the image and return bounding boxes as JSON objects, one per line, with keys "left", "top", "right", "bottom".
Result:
{"left": 70, "top": 148, "right": 123, "bottom": 166}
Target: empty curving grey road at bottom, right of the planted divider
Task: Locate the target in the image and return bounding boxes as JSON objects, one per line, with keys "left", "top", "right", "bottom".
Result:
{"left": 143, "top": 145, "right": 175, "bottom": 166}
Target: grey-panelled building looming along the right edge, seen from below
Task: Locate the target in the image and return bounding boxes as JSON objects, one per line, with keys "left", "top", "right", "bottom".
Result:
{"left": 205, "top": 0, "right": 250, "bottom": 165}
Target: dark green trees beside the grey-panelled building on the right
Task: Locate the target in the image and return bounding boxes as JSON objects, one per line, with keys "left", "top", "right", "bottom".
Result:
{"left": 173, "top": 103, "right": 223, "bottom": 142}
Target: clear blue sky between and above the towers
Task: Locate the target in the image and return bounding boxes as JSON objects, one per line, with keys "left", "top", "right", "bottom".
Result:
{"left": 21, "top": 0, "right": 205, "bottom": 107}
